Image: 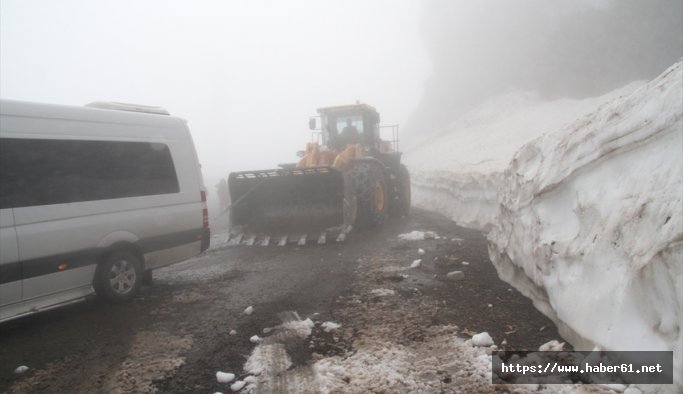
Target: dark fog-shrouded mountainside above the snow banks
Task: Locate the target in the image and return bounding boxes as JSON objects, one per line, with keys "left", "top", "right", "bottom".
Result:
{"left": 404, "top": 0, "right": 683, "bottom": 142}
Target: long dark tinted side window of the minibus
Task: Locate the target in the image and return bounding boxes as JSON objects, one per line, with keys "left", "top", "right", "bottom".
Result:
{"left": 0, "top": 138, "right": 180, "bottom": 208}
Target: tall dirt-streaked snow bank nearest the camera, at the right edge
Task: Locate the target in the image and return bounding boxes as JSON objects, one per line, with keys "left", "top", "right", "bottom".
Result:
{"left": 489, "top": 62, "right": 683, "bottom": 386}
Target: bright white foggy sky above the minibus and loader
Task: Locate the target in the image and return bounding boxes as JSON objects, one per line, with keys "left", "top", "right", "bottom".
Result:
{"left": 0, "top": 0, "right": 430, "bottom": 183}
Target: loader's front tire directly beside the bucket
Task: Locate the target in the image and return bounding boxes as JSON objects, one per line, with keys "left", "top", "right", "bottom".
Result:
{"left": 351, "top": 163, "right": 389, "bottom": 228}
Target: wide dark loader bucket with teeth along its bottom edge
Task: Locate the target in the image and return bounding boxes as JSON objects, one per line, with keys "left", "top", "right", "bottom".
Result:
{"left": 228, "top": 167, "right": 344, "bottom": 242}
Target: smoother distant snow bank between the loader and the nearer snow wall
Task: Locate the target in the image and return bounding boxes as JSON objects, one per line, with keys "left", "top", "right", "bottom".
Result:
{"left": 405, "top": 82, "right": 643, "bottom": 230}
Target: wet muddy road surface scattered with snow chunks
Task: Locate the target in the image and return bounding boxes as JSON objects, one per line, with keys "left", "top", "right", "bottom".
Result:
{"left": 0, "top": 210, "right": 561, "bottom": 393}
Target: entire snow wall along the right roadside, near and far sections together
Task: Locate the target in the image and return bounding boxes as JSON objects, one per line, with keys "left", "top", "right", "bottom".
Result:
{"left": 406, "top": 61, "right": 683, "bottom": 388}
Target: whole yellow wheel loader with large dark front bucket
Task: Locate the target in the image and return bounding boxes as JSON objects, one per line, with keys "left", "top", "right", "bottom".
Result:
{"left": 228, "top": 104, "right": 410, "bottom": 246}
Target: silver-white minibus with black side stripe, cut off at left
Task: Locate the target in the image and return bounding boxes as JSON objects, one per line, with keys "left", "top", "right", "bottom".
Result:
{"left": 0, "top": 100, "right": 209, "bottom": 321}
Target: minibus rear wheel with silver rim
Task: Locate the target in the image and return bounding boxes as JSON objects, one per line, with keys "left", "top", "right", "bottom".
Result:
{"left": 93, "top": 251, "right": 143, "bottom": 302}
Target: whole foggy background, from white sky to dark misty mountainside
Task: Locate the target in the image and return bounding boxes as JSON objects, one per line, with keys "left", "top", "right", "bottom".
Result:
{"left": 0, "top": 0, "right": 683, "bottom": 186}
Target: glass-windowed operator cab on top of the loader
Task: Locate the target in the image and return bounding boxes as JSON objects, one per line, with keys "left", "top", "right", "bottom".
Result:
{"left": 318, "top": 104, "right": 380, "bottom": 151}
